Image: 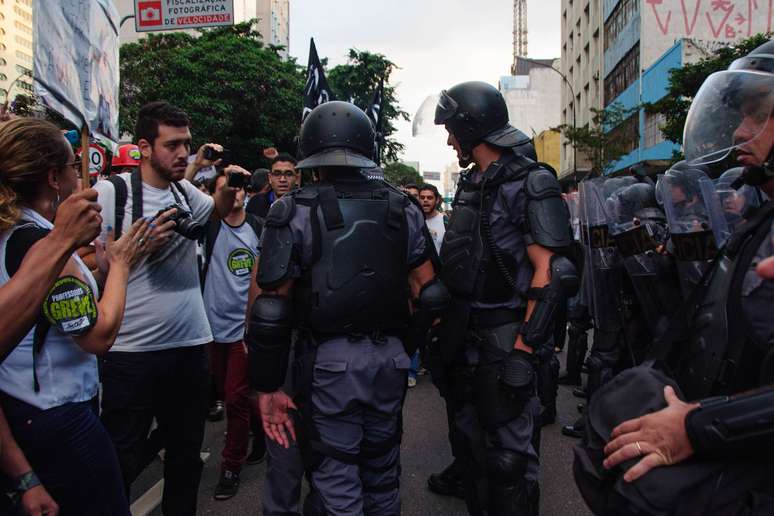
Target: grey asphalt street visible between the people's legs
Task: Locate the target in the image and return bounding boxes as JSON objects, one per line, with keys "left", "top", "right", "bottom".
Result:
{"left": 132, "top": 348, "right": 591, "bottom": 516}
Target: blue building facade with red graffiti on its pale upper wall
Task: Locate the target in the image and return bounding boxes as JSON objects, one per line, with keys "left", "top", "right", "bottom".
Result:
{"left": 603, "top": 0, "right": 774, "bottom": 173}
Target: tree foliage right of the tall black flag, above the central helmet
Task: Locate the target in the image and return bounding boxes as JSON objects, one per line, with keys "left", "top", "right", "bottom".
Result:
{"left": 327, "top": 48, "right": 409, "bottom": 162}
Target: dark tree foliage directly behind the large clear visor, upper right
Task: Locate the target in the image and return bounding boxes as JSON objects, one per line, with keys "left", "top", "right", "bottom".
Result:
{"left": 644, "top": 34, "right": 771, "bottom": 145}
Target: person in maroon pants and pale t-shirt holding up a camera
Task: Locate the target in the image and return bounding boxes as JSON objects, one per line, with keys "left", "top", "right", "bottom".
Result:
{"left": 204, "top": 171, "right": 265, "bottom": 500}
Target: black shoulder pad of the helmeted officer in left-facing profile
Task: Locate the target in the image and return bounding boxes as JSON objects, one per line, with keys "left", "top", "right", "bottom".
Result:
{"left": 524, "top": 168, "right": 573, "bottom": 251}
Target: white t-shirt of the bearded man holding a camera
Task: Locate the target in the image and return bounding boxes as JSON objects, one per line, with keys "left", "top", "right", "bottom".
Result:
{"left": 94, "top": 174, "right": 214, "bottom": 352}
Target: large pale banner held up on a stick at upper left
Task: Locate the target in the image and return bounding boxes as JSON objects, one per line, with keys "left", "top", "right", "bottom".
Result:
{"left": 33, "top": 0, "right": 119, "bottom": 142}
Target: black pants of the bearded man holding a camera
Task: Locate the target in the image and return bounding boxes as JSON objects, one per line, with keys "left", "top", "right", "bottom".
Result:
{"left": 101, "top": 346, "right": 209, "bottom": 516}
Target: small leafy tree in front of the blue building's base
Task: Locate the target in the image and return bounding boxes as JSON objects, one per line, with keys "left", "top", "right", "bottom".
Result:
{"left": 557, "top": 103, "right": 638, "bottom": 176}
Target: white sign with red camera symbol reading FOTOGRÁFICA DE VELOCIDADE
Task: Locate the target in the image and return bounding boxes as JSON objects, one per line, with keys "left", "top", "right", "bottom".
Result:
{"left": 134, "top": 0, "right": 234, "bottom": 32}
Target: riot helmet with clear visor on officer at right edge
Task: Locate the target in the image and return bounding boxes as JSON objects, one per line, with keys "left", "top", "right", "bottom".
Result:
{"left": 683, "top": 40, "right": 774, "bottom": 186}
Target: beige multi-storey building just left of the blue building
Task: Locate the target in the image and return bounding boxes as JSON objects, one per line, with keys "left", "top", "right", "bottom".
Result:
{"left": 558, "top": 0, "right": 608, "bottom": 178}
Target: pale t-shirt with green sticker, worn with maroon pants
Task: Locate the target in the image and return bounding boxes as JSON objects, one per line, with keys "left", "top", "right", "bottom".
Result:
{"left": 204, "top": 221, "right": 260, "bottom": 343}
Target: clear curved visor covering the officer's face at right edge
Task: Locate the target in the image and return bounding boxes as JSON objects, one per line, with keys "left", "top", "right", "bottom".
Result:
{"left": 683, "top": 70, "right": 774, "bottom": 164}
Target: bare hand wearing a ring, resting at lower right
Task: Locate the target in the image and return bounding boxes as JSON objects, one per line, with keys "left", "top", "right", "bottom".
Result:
{"left": 603, "top": 386, "right": 698, "bottom": 482}
